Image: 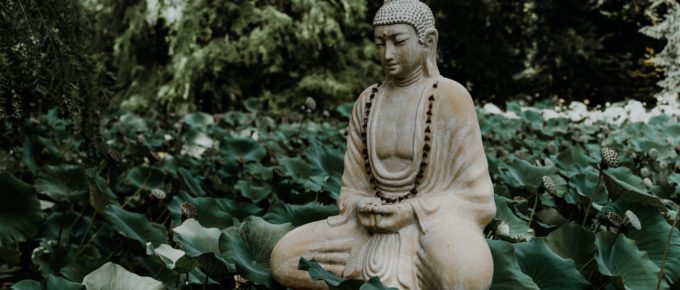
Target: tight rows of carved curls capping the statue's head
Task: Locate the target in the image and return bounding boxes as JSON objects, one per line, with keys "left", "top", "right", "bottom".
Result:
{"left": 373, "top": 0, "right": 435, "bottom": 43}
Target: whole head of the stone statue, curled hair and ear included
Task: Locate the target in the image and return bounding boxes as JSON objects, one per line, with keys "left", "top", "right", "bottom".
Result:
{"left": 373, "top": 0, "right": 439, "bottom": 78}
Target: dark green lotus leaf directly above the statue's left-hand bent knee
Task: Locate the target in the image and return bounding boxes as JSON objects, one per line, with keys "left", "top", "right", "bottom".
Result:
{"left": 264, "top": 202, "right": 338, "bottom": 227}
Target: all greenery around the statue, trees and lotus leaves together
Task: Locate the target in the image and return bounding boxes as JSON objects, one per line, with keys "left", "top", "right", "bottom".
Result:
{"left": 0, "top": 0, "right": 680, "bottom": 289}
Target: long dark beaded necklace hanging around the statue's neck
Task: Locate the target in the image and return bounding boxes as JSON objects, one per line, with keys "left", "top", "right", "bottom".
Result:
{"left": 361, "top": 81, "right": 439, "bottom": 204}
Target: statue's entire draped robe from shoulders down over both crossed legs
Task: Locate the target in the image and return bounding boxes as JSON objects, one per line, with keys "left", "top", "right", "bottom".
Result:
{"left": 272, "top": 78, "right": 496, "bottom": 290}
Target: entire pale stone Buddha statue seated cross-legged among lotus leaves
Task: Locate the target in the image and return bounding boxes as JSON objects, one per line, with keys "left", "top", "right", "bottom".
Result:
{"left": 271, "top": 0, "right": 496, "bottom": 290}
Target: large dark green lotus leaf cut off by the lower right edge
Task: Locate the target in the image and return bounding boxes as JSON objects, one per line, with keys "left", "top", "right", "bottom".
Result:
{"left": 626, "top": 207, "right": 680, "bottom": 284}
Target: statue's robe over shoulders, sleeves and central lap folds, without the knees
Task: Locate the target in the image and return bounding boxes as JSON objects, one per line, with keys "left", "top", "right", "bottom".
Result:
{"left": 328, "top": 78, "right": 496, "bottom": 289}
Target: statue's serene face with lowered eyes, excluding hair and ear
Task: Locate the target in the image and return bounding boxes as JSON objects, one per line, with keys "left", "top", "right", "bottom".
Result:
{"left": 374, "top": 24, "right": 427, "bottom": 78}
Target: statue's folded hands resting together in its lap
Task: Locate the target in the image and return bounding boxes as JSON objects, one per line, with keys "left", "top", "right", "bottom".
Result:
{"left": 357, "top": 198, "right": 414, "bottom": 233}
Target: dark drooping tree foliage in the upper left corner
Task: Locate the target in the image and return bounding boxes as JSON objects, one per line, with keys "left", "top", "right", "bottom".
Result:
{"left": 0, "top": 0, "right": 113, "bottom": 152}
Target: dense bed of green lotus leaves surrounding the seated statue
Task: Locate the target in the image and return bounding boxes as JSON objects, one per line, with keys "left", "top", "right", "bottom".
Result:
{"left": 0, "top": 100, "right": 680, "bottom": 289}
